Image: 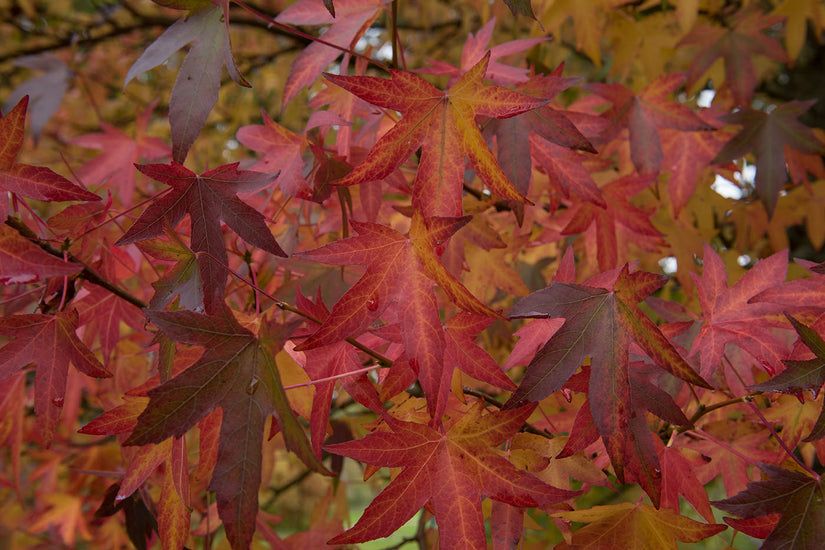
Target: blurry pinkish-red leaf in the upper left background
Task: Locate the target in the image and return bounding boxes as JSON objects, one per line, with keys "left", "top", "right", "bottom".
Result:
{"left": 71, "top": 104, "right": 171, "bottom": 206}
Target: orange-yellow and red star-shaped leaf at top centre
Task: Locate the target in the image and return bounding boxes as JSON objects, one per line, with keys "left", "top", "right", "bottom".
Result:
{"left": 325, "top": 54, "right": 547, "bottom": 217}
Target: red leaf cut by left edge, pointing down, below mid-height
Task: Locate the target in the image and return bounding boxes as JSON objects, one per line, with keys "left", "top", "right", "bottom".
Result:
{"left": 0, "top": 310, "right": 111, "bottom": 445}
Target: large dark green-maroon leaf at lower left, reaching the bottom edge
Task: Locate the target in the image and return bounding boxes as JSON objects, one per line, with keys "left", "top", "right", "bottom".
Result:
{"left": 125, "top": 309, "right": 326, "bottom": 548}
